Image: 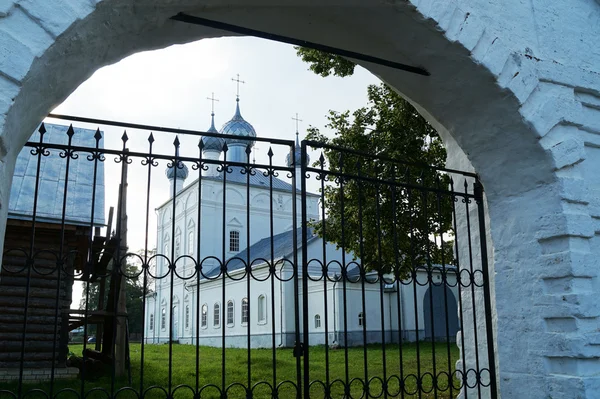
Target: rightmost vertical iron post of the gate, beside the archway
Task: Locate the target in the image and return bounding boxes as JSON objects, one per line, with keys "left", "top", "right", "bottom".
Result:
{"left": 474, "top": 179, "right": 498, "bottom": 399}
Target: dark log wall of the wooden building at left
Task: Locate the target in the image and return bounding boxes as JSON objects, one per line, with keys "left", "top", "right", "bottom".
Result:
{"left": 0, "top": 219, "right": 90, "bottom": 368}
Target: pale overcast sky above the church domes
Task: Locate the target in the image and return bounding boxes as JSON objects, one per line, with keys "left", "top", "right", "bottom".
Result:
{"left": 48, "top": 37, "right": 379, "bottom": 306}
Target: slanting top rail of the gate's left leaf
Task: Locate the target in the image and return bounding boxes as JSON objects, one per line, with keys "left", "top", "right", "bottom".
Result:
{"left": 48, "top": 114, "right": 295, "bottom": 146}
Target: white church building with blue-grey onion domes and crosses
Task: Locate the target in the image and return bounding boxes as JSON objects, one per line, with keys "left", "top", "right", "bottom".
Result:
{"left": 144, "top": 98, "right": 460, "bottom": 348}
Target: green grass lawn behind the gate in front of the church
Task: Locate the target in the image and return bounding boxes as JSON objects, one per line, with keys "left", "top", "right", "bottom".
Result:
{"left": 0, "top": 342, "right": 459, "bottom": 399}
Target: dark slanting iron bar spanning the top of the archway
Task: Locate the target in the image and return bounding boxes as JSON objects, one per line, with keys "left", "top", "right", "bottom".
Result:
{"left": 171, "top": 13, "right": 431, "bottom": 76}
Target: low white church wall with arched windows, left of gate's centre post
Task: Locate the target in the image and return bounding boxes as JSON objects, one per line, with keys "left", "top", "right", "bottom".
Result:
{"left": 146, "top": 266, "right": 294, "bottom": 348}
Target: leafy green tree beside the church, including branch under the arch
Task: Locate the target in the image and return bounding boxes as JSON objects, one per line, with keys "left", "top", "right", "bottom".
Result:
{"left": 298, "top": 48, "right": 453, "bottom": 277}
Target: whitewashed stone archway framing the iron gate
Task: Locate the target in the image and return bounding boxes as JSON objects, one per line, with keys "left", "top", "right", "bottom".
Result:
{"left": 0, "top": 0, "right": 600, "bottom": 397}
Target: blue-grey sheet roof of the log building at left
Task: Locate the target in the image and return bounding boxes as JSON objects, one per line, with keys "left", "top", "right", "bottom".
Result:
{"left": 8, "top": 123, "right": 104, "bottom": 225}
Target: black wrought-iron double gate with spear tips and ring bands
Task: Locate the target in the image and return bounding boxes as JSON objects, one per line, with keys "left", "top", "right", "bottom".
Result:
{"left": 0, "top": 115, "right": 497, "bottom": 398}
